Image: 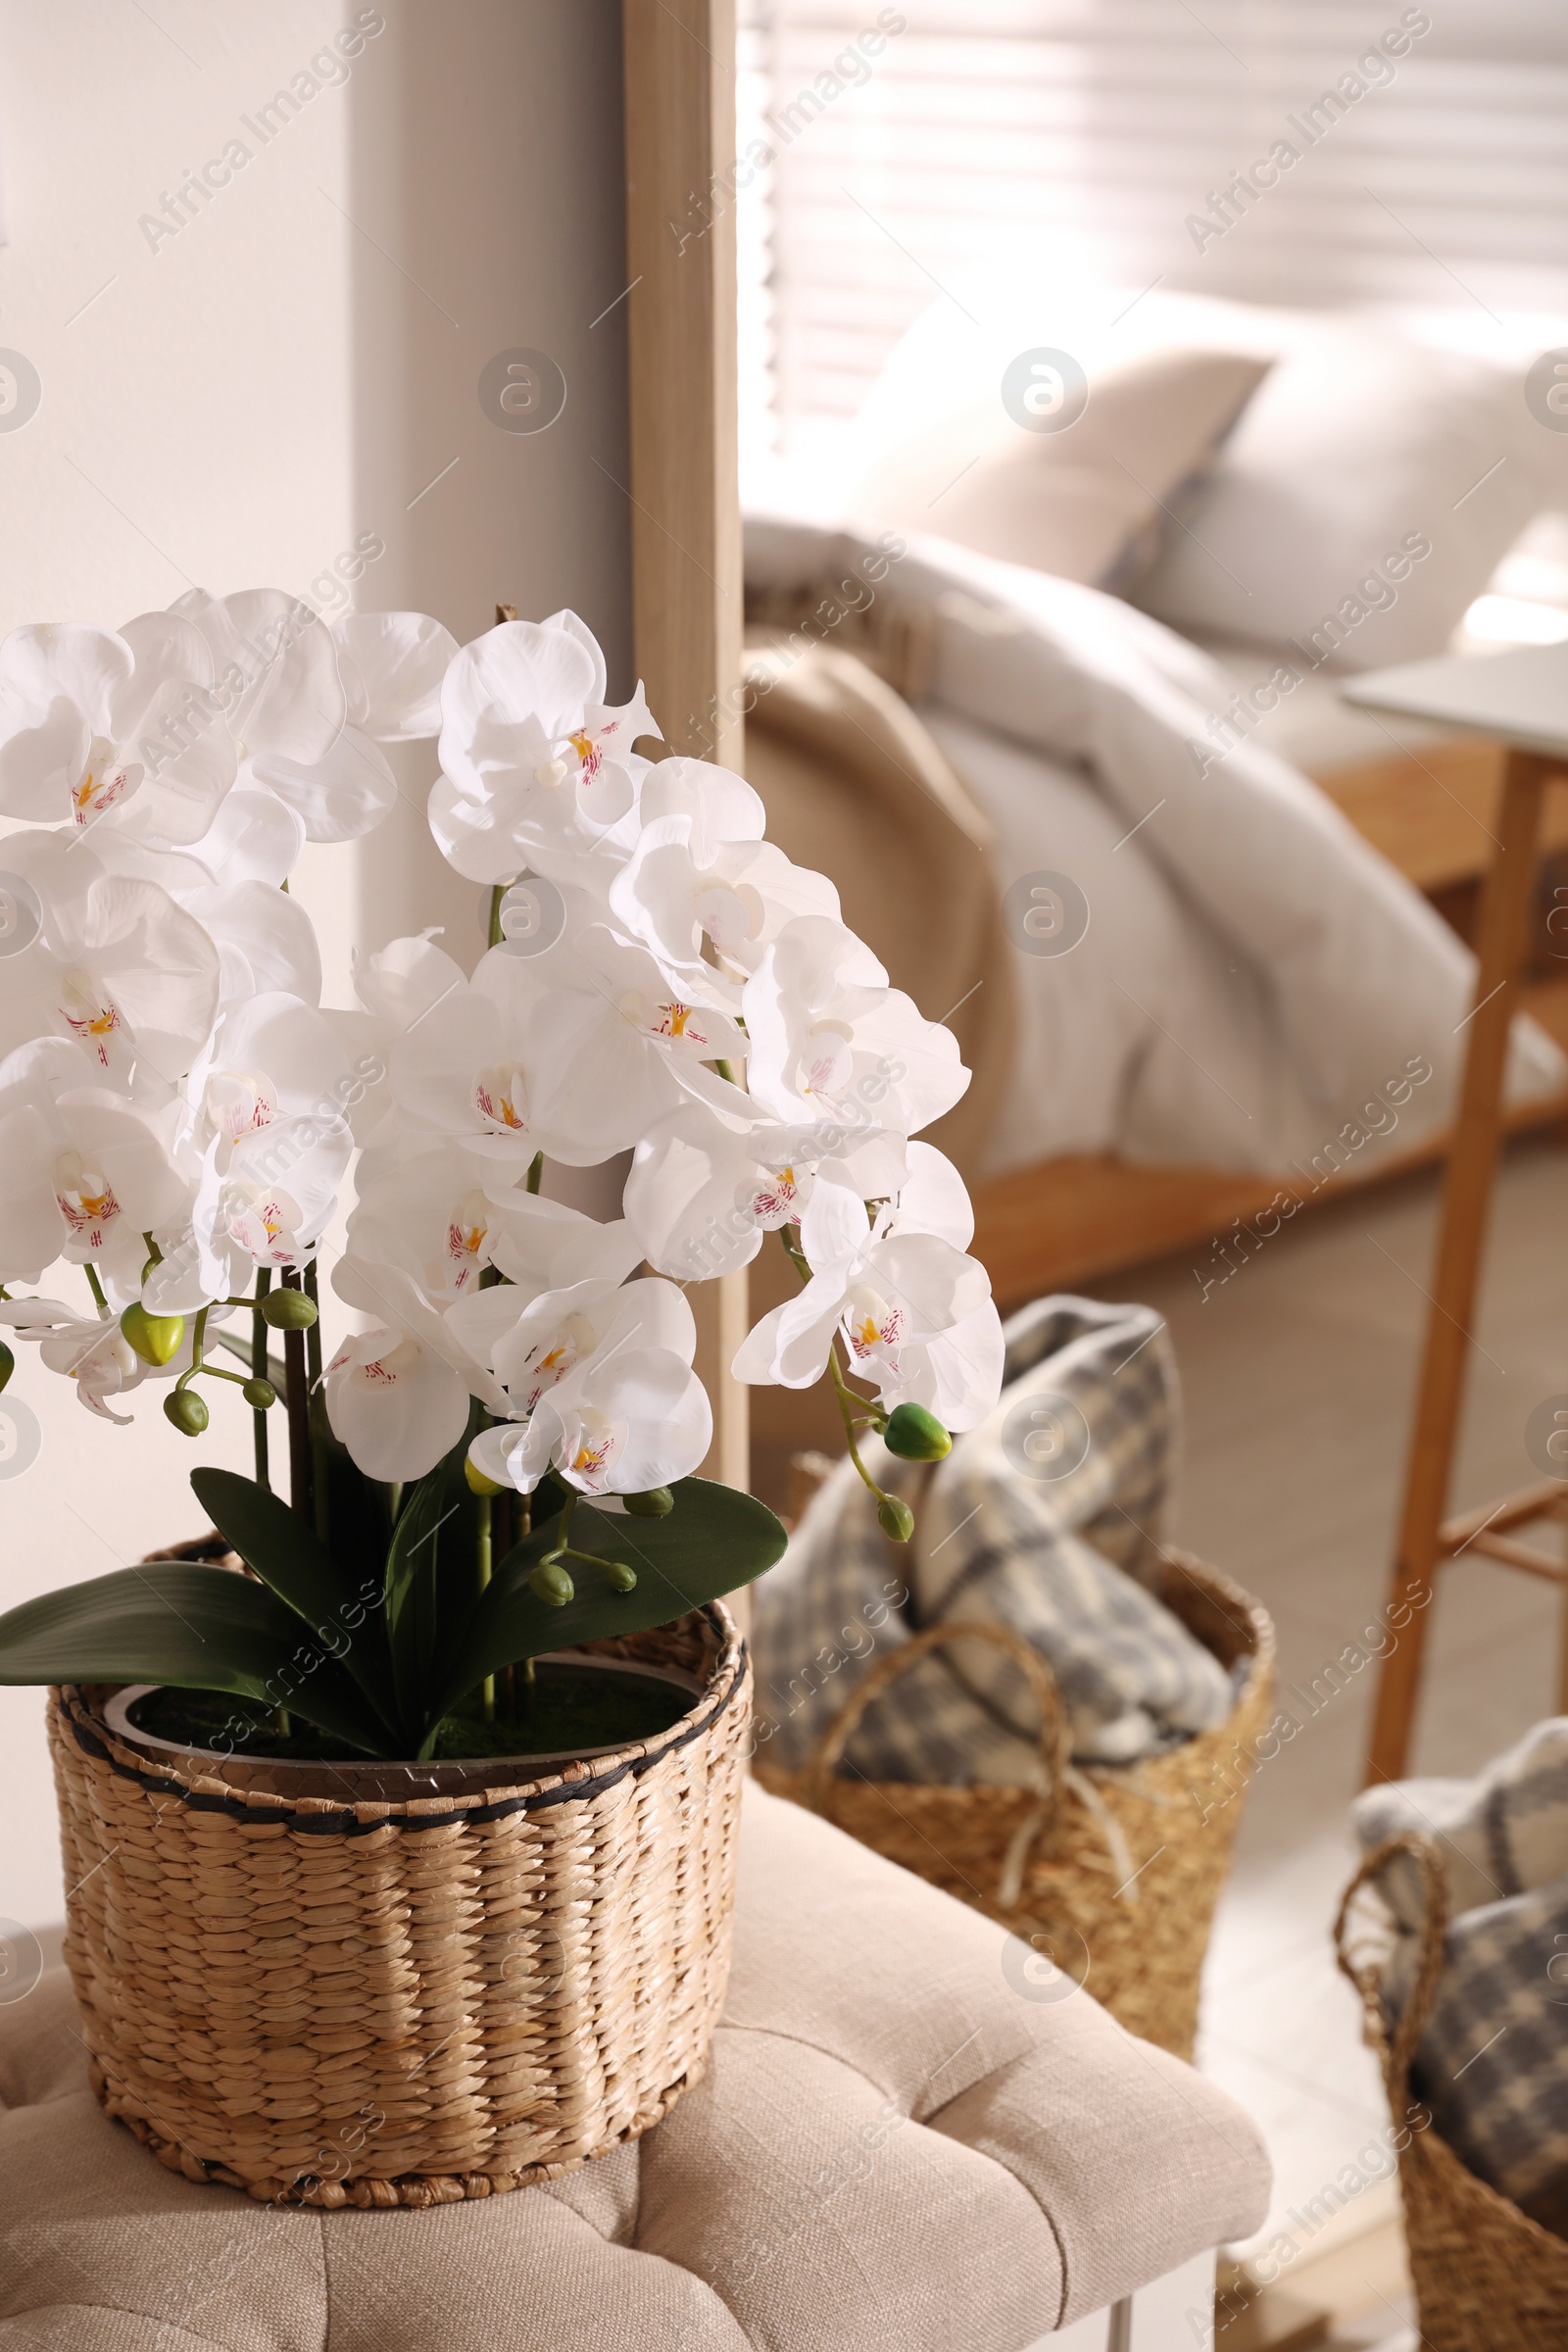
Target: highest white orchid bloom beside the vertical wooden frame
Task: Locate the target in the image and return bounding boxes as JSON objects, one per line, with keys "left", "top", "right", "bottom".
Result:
{"left": 430, "top": 612, "right": 659, "bottom": 884}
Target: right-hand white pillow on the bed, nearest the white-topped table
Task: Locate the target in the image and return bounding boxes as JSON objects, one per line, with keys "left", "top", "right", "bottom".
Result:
{"left": 1136, "top": 319, "right": 1543, "bottom": 670}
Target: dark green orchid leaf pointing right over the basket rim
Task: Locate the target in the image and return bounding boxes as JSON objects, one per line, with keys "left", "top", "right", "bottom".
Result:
{"left": 430, "top": 1477, "right": 788, "bottom": 1722}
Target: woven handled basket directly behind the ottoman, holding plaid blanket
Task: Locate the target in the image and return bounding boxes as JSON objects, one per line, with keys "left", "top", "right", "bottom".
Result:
{"left": 757, "top": 1552, "right": 1274, "bottom": 2058}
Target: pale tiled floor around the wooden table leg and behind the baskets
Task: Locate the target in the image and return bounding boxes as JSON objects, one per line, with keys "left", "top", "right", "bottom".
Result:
{"left": 1101, "top": 1143, "right": 1568, "bottom": 2352}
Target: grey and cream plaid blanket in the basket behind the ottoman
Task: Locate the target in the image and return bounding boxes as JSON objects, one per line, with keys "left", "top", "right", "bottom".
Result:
{"left": 753, "top": 1296, "right": 1234, "bottom": 1788}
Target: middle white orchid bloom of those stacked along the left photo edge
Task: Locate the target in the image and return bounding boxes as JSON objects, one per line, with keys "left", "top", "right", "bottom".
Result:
{"left": 0, "top": 833, "right": 219, "bottom": 1087}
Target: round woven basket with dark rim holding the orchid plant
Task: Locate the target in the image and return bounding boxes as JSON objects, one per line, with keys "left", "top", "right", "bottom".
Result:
{"left": 49, "top": 1604, "right": 750, "bottom": 2206}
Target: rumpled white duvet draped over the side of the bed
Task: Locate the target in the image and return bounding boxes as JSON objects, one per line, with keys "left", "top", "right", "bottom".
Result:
{"left": 748, "top": 519, "right": 1568, "bottom": 1174}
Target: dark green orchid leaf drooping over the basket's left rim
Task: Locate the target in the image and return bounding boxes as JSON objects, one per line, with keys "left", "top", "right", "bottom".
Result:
{"left": 0, "top": 1559, "right": 385, "bottom": 1754}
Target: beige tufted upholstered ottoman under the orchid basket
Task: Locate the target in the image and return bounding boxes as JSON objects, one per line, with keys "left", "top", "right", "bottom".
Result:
{"left": 0, "top": 1788, "right": 1267, "bottom": 2352}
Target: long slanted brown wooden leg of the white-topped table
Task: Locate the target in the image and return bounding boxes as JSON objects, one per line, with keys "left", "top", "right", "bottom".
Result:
{"left": 1366, "top": 751, "right": 1556, "bottom": 1781}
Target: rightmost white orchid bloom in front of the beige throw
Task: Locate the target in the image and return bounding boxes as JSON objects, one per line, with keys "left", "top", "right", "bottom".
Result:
{"left": 741, "top": 915, "right": 968, "bottom": 1136}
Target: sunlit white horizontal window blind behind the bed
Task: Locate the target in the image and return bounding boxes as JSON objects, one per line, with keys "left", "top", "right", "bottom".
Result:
{"left": 738, "top": 0, "right": 1568, "bottom": 449}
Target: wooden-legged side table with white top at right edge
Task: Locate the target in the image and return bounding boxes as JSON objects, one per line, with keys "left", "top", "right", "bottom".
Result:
{"left": 1343, "top": 645, "right": 1568, "bottom": 1781}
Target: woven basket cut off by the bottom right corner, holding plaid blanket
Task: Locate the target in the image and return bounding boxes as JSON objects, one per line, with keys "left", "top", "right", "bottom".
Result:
{"left": 1333, "top": 1833, "right": 1568, "bottom": 2352}
